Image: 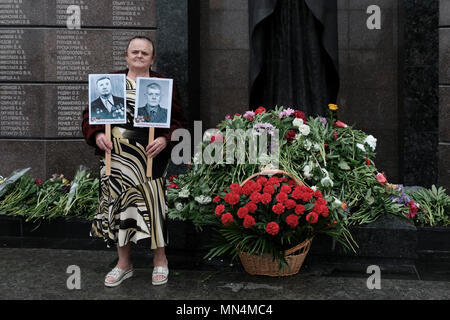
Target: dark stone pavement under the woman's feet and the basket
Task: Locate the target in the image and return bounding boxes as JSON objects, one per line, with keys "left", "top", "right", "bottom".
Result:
{"left": 0, "top": 248, "right": 450, "bottom": 305}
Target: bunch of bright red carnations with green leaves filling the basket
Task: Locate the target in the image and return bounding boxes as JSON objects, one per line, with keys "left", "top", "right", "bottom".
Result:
{"left": 207, "top": 174, "right": 338, "bottom": 263}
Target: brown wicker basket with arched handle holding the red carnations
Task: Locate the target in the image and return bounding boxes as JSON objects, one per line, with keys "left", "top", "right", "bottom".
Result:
{"left": 239, "top": 170, "right": 312, "bottom": 277}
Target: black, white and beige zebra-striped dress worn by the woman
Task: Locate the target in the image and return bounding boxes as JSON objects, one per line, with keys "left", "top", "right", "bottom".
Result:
{"left": 91, "top": 77, "right": 168, "bottom": 249}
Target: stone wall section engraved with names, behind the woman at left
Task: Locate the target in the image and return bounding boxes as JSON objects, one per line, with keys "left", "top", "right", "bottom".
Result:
{"left": 0, "top": 0, "right": 166, "bottom": 178}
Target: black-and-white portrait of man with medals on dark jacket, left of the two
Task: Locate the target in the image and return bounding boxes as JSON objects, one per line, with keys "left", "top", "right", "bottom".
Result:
{"left": 89, "top": 74, "right": 127, "bottom": 124}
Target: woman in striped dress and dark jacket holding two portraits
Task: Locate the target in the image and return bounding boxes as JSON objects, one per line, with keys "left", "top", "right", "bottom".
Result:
{"left": 82, "top": 36, "right": 185, "bottom": 287}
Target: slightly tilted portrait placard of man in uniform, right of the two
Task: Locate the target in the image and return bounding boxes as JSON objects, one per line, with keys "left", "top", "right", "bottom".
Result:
{"left": 134, "top": 77, "right": 173, "bottom": 128}
